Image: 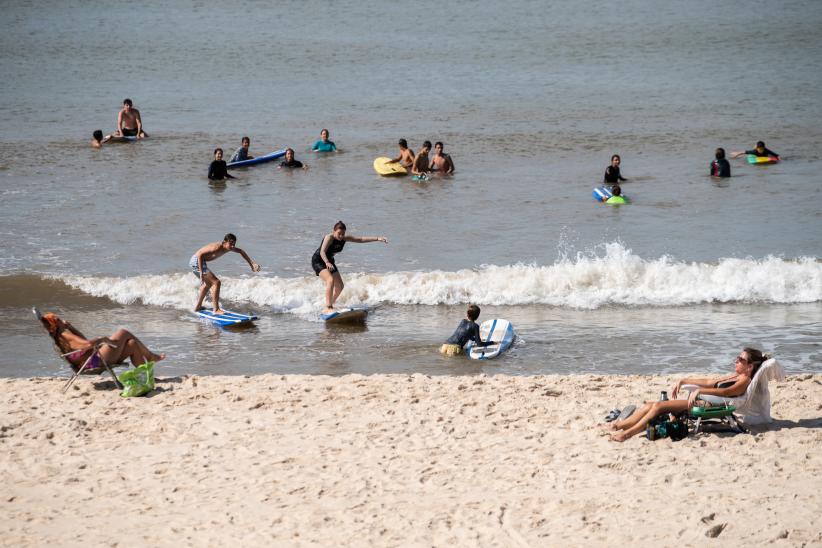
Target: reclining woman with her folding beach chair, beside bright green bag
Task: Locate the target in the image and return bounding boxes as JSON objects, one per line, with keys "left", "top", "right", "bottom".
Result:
{"left": 35, "top": 310, "right": 166, "bottom": 388}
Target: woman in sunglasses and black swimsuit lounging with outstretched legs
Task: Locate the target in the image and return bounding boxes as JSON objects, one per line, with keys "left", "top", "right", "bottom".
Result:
{"left": 603, "top": 348, "right": 765, "bottom": 441}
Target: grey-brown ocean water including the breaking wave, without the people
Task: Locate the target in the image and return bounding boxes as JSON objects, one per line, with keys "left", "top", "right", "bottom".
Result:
{"left": 0, "top": 0, "right": 822, "bottom": 376}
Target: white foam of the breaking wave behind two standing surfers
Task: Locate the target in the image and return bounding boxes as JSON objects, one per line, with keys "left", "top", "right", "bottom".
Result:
{"left": 59, "top": 243, "right": 822, "bottom": 314}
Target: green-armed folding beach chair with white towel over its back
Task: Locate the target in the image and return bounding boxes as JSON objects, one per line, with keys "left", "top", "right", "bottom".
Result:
{"left": 682, "top": 358, "right": 785, "bottom": 433}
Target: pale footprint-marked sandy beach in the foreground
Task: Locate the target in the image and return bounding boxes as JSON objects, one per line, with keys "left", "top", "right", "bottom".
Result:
{"left": 0, "top": 374, "right": 822, "bottom": 546}
